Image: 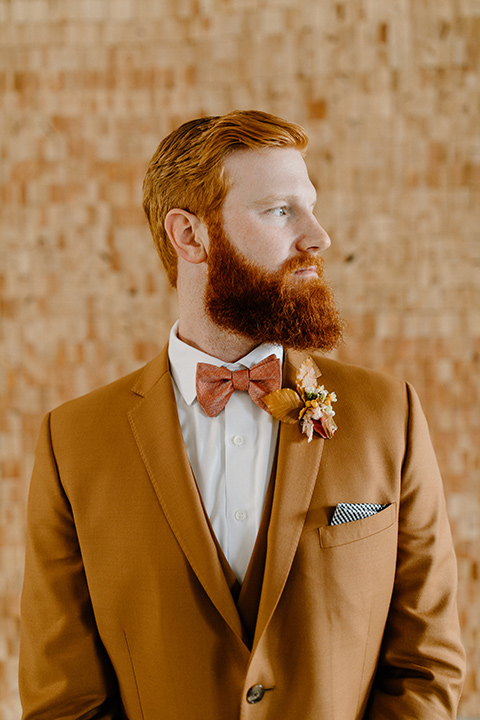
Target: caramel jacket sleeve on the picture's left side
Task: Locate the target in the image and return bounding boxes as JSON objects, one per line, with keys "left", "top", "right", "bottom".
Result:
{"left": 19, "top": 416, "right": 120, "bottom": 720}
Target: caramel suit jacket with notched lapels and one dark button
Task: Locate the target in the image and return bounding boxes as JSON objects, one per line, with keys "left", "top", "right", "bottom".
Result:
{"left": 20, "top": 349, "right": 464, "bottom": 720}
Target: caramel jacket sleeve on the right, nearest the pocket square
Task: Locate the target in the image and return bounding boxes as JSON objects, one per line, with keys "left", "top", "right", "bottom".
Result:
{"left": 366, "top": 386, "right": 465, "bottom": 720}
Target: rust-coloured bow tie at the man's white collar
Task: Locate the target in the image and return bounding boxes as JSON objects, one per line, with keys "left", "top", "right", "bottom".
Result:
{"left": 197, "top": 354, "right": 282, "bottom": 417}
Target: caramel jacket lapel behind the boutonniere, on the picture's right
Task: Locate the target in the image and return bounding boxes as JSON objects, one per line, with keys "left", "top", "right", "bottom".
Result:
{"left": 253, "top": 352, "right": 325, "bottom": 650}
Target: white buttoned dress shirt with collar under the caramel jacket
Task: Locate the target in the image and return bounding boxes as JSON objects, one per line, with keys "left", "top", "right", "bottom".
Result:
{"left": 168, "top": 322, "right": 283, "bottom": 582}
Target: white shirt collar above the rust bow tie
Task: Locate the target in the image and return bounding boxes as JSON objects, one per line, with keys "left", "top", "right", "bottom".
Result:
{"left": 168, "top": 320, "right": 283, "bottom": 405}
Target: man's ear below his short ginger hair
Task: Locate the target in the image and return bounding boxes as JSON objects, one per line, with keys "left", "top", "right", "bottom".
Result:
{"left": 165, "top": 208, "right": 208, "bottom": 263}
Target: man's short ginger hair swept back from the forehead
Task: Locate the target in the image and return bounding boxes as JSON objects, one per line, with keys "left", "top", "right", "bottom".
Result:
{"left": 143, "top": 110, "right": 308, "bottom": 287}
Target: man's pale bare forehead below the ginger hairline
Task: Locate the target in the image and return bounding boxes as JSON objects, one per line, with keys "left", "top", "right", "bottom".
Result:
{"left": 224, "top": 147, "right": 315, "bottom": 203}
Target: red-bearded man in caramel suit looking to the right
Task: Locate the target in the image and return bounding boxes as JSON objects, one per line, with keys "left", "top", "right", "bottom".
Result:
{"left": 20, "top": 112, "right": 463, "bottom": 720}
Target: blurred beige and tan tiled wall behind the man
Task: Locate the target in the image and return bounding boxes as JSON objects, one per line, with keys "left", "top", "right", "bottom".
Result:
{"left": 0, "top": 0, "right": 480, "bottom": 720}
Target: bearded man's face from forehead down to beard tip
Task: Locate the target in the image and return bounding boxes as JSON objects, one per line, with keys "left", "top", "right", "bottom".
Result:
{"left": 205, "top": 149, "right": 343, "bottom": 350}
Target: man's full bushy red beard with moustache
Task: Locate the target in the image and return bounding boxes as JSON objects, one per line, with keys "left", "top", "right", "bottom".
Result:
{"left": 204, "top": 220, "right": 344, "bottom": 352}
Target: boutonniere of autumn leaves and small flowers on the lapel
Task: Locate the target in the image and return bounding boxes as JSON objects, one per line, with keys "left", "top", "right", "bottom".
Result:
{"left": 262, "top": 357, "right": 337, "bottom": 442}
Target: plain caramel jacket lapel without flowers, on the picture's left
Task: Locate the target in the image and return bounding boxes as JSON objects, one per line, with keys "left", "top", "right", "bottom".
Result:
{"left": 129, "top": 348, "right": 242, "bottom": 638}
